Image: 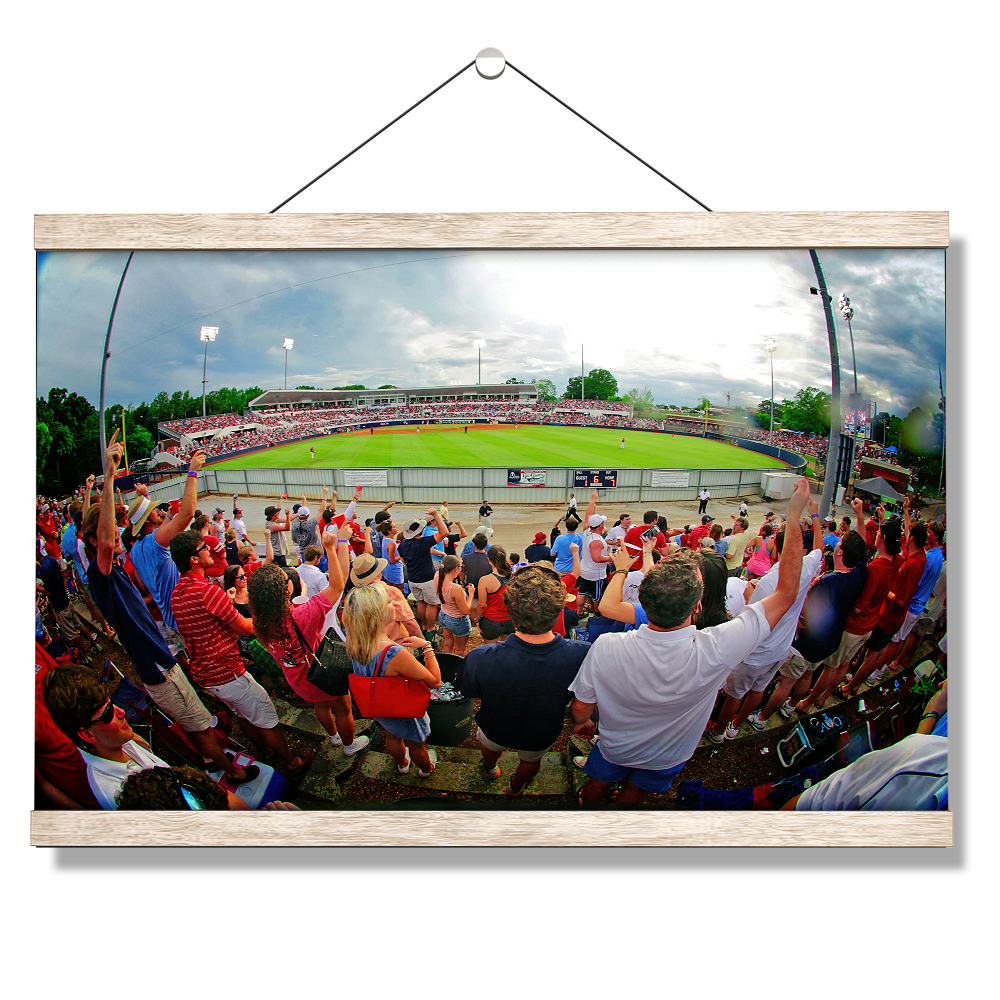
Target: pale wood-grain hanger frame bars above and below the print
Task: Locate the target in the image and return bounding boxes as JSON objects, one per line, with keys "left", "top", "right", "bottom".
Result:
{"left": 30, "top": 212, "right": 954, "bottom": 847}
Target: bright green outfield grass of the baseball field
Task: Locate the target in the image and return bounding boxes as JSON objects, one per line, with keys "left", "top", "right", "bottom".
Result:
{"left": 211, "top": 425, "right": 785, "bottom": 469}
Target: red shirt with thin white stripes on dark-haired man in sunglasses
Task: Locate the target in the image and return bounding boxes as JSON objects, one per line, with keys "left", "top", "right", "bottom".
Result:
{"left": 170, "top": 573, "right": 245, "bottom": 687}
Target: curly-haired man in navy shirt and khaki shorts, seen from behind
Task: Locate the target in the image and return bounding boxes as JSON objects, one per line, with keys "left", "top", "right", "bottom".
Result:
{"left": 460, "top": 566, "right": 590, "bottom": 796}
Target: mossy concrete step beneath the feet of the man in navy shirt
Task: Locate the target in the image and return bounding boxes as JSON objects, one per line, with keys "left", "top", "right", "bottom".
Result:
{"left": 360, "top": 747, "right": 582, "bottom": 795}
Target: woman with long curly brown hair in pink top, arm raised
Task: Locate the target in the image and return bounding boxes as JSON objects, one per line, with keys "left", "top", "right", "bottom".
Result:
{"left": 247, "top": 523, "right": 368, "bottom": 756}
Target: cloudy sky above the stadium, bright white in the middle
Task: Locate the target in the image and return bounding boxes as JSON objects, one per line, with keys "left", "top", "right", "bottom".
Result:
{"left": 37, "top": 250, "right": 947, "bottom": 415}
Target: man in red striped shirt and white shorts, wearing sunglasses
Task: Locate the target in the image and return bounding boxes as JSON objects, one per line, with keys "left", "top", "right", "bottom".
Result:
{"left": 170, "top": 530, "right": 303, "bottom": 771}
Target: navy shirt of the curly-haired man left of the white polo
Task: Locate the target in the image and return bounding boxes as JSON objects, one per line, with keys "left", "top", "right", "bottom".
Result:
{"left": 460, "top": 635, "right": 590, "bottom": 751}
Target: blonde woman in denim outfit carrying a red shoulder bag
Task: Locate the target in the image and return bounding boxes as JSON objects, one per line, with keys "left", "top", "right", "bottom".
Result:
{"left": 344, "top": 587, "right": 441, "bottom": 778}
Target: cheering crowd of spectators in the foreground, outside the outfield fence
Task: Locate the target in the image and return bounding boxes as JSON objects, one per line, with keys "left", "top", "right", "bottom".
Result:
{"left": 36, "top": 432, "right": 947, "bottom": 809}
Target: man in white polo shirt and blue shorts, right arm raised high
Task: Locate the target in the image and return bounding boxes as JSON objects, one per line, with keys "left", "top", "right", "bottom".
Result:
{"left": 570, "top": 479, "right": 809, "bottom": 807}
